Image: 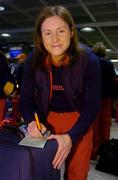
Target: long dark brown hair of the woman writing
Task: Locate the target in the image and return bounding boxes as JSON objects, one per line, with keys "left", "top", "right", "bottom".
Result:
{"left": 33, "top": 6, "right": 81, "bottom": 68}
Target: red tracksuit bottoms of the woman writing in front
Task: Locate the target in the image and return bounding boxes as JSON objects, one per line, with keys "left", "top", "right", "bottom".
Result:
{"left": 47, "top": 111, "right": 93, "bottom": 180}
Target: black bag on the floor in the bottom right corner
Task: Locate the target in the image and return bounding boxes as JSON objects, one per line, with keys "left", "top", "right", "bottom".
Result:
{"left": 95, "top": 139, "right": 118, "bottom": 176}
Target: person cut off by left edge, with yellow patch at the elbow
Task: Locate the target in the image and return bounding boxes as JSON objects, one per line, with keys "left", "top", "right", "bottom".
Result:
{"left": 0, "top": 51, "right": 14, "bottom": 121}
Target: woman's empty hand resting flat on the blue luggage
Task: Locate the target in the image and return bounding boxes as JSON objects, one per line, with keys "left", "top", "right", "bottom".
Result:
{"left": 47, "top": 134, "right": 72, "bottom": 169}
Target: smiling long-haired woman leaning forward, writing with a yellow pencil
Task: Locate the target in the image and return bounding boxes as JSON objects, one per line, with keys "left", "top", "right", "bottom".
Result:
{"left": 21, "top": 6, "right": 100, "bottom": 180}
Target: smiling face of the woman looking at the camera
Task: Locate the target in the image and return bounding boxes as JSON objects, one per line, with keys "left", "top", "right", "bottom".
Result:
{"left": 41, "top": 16, "right": 72, "bottom": 59}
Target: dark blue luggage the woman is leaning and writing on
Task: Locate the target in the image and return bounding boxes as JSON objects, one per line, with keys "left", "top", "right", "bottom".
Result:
{"left": 0, "top": 127, "right": 61, "bottom": 180}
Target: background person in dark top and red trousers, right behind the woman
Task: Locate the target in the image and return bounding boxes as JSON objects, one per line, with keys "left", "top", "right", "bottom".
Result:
{"left": 92, "top": 42, "right": 116, "bottom": 159}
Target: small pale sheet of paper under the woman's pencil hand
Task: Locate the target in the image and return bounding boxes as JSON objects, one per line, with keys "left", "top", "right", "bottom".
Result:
{"left": 19, "top": 136, "right": 47, "bottom": 148}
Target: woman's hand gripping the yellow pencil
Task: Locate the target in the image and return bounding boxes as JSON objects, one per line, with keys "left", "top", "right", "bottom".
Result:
{"left": 27, "top": 121, "right": 46, "bottom": 138}
